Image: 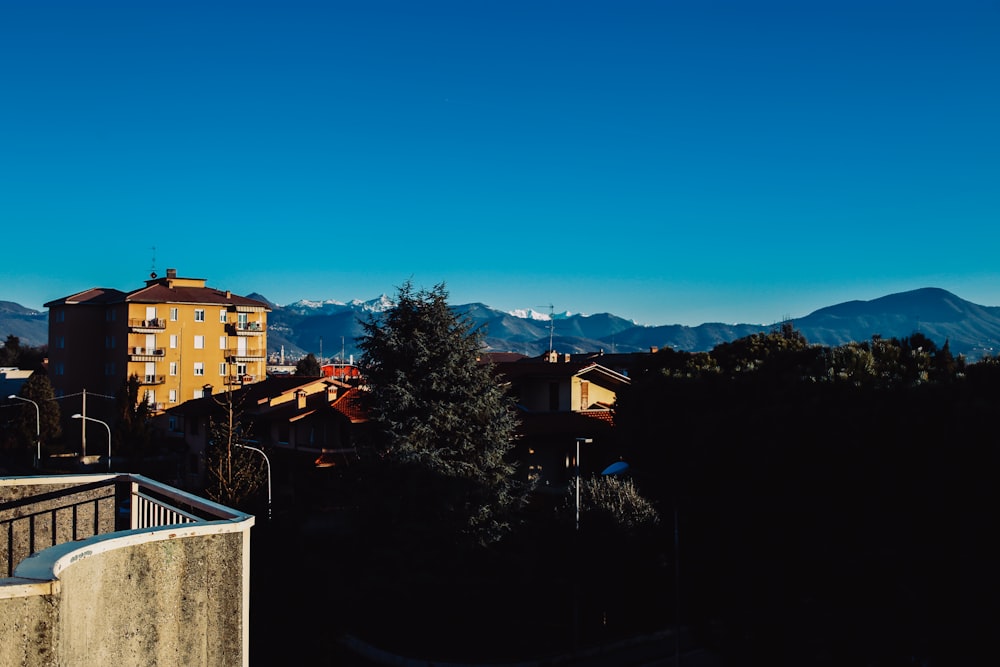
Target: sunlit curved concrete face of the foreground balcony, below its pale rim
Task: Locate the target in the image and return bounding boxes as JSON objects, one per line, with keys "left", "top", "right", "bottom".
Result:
{"left": 56, "top": 533, "right": 249, "bottom": 667}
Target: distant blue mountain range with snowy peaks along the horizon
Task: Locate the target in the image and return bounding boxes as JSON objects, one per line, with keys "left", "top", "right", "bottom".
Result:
{"left": 0, "top": 287, "right": 1000, "bottom": 363}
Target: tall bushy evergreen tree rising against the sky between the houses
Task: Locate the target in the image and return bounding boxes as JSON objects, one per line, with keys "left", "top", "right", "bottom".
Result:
{"left": 359, "top": 282, "right": 527, "bottom": 545}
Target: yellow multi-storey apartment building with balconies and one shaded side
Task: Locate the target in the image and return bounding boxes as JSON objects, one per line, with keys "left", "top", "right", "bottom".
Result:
{"left": 45, "top": 269, "right": 271, "bottom": 412}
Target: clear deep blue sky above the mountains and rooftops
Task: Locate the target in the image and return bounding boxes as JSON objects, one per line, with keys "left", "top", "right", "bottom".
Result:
{"left": 0, "top": 0, "right": 1000, "bottom": 325}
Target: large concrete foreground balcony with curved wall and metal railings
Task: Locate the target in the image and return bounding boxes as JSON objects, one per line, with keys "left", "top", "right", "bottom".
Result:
{"left": 0, "top": 474, "right": 254, "bottom": 667}
